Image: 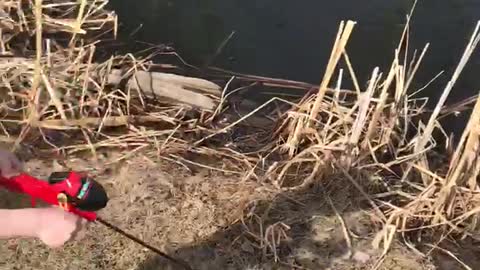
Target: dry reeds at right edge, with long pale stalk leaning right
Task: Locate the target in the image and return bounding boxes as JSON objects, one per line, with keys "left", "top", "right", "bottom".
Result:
{"left": 375, "top": 21, "right": 480, "bottom": 260}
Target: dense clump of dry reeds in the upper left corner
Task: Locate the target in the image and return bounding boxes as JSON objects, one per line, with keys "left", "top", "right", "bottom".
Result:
{"left": 0, "top": 0, "right": 116, "bottom": 133}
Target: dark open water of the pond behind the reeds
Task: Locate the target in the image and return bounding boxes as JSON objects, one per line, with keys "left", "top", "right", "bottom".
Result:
{"left": 111, "top": 0, "right": 480, "bottom": 134}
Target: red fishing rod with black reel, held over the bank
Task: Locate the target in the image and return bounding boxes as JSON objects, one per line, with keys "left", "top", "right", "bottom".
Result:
{"left": 0, "top": 172, "right": 192, "bottom": 270}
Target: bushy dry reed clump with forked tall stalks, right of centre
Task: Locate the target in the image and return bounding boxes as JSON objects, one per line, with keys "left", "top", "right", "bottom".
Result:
{"left": 262, "top": 21, "right": 428, "bottom": 189}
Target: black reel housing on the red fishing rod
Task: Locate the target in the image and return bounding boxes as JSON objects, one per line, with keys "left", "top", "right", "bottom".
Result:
{"left": 48, "top": 172, "right": 109, "bottom": 212}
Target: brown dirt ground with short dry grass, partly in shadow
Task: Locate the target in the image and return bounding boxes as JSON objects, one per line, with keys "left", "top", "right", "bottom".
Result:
{"left": 0, "top": 153, "right": 474, "bottom": 270}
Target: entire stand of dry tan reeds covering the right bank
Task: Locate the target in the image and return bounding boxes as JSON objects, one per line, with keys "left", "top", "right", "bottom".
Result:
{"left": 255, "top": 7, "right": 480, "bottom": 264}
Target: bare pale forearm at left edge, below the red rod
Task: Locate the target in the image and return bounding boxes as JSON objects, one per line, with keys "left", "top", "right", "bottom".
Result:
{"left": 0, "top": 208, "right": 40, "bottom": 238}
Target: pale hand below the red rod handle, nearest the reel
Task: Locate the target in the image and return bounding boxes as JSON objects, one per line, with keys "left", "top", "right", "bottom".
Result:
{"left": 35, "top": 207, "right": 87, "bottom": 248}
